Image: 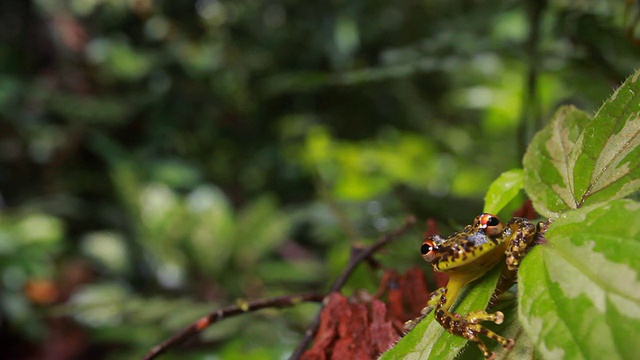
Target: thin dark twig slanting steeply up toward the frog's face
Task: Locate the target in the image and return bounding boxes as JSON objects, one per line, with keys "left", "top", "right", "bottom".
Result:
{"left": 289, "top": 216, "right": 416, "bottom": 360}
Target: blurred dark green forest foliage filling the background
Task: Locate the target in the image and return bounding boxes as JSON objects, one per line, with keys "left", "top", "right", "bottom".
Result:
{"left": 0, "top": 0, "right": 640, "bottom": 359}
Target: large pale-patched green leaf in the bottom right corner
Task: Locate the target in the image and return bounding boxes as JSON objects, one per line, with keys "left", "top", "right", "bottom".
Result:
{"left": 518, "top": 200, "right": 640, "bottom": 359}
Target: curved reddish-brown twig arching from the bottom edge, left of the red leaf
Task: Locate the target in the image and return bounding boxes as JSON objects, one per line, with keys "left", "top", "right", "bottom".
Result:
{"left": 143, "top": 293, "right": 324, "bottom": 360}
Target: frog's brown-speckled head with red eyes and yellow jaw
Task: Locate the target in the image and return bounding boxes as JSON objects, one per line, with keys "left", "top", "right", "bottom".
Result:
{"left": 420, "top": 213, "right": 505, "bottom": 271}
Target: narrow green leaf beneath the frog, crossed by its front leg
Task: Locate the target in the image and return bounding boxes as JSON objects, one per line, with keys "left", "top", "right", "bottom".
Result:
{"left": 380, "top": 266, "right": 503, "bottom": 360}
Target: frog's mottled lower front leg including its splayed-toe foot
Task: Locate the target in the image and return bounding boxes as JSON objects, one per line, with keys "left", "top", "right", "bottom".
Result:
{"left": 435, "top": 289, "right": 514, "bottom": 359}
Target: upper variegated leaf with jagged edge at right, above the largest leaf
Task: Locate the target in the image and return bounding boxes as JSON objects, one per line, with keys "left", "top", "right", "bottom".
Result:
{"left": 523, "top": 71, "right": 640, "bottom": 218}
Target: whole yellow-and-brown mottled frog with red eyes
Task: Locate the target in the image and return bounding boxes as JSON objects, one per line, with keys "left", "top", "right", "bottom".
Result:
{"left": 405, "top": 213, "right": 537, "bottom": 359}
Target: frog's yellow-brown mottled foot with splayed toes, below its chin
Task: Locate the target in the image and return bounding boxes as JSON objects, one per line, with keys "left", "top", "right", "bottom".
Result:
{"left": 436, "top": 311, "right": 515, "bottom": 359}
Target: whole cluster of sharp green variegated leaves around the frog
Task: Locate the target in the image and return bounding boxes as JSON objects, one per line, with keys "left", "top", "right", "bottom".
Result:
{"left": 383, "top": 71, "right": 640, "bottom": 359}
